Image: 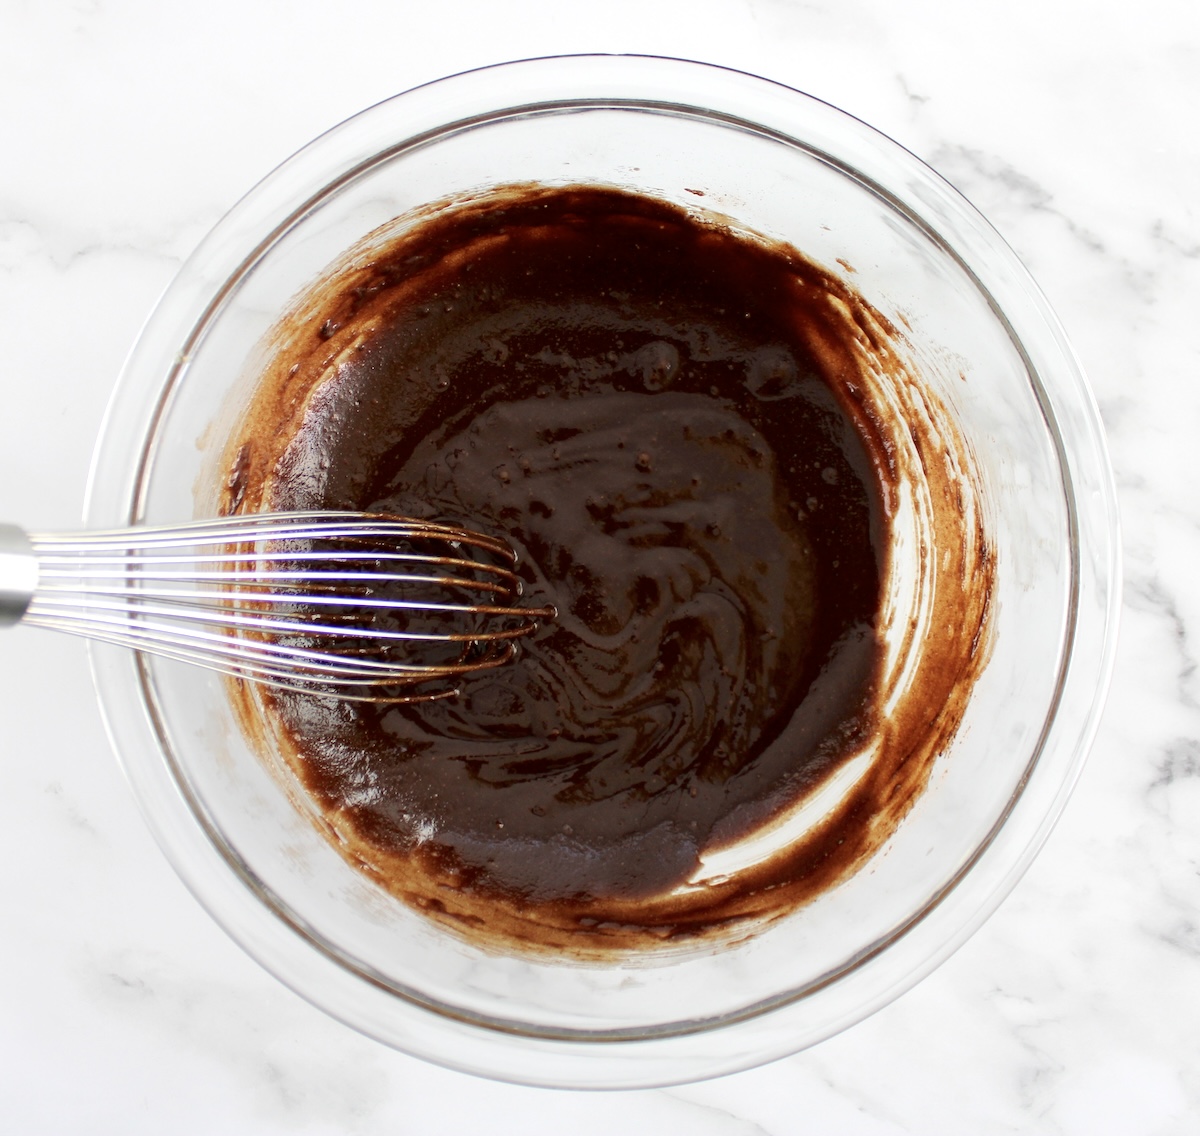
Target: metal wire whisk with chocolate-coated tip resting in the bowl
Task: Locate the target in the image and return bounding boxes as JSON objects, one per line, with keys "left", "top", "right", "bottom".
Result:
{"left": 0, "top": 512, "right": 554, "bottom": 702}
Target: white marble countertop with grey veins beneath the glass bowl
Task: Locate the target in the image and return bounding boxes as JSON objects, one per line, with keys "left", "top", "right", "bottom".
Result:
{"left": 0, "top": 0, "right": 1200, "bottom": 1136}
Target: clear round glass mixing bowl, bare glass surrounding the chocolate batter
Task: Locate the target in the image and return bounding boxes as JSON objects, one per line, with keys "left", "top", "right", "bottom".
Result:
{"left": 88, "top": 56, "right": 1118, "bottom": 1087}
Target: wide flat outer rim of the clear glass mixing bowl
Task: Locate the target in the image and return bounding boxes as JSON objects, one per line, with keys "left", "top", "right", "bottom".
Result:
{"left": 85, "top": 55, "right": 1121, "bottom": 1088}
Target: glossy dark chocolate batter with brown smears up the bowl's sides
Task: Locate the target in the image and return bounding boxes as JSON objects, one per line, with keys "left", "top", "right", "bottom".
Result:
{"left": 226, "top": 186, "right": 992, "bottom": 957}
